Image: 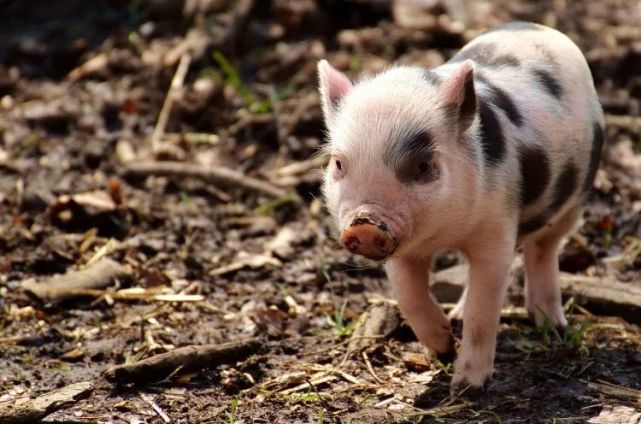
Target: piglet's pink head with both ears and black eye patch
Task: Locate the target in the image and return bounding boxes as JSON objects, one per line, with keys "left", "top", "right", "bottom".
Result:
{"left": 318, "top": 60, "right": 477, "bottom": 260}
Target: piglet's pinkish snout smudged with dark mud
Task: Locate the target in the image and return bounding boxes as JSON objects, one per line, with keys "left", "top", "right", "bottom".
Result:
{"left": 341, "top": 212, "right": 398, "bottom": 260}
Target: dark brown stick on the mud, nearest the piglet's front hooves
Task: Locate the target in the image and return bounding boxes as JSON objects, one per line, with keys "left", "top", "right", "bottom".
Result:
{"left": 103, "top": 339, "right": 261, "bottom": 384}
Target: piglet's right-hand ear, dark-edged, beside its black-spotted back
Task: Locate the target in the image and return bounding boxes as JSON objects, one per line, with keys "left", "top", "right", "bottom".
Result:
{"left": 441, "top": 60, "right": 478, "bottom": 132}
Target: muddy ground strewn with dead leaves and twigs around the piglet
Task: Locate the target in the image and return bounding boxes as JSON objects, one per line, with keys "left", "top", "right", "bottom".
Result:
{"left": 0, "top": 0, "right": 641, "bottom": 423}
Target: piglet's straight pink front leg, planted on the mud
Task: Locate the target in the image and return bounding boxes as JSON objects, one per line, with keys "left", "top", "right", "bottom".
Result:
{"left": 452, "top": 237, "right": 514, "bottom": 392}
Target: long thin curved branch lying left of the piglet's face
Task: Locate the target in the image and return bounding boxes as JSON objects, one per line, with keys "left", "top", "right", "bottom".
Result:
{"left": 126, "top": 161, "right": 288, "bottom": 198}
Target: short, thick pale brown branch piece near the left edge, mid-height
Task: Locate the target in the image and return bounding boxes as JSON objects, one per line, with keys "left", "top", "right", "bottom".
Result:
{"left": 22, "top": 258, "right": 131, "bottom": 301}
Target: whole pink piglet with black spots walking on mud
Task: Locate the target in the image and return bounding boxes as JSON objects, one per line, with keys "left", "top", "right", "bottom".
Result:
{"left": 319, "top": 23, "right": 604, "bottom": 388}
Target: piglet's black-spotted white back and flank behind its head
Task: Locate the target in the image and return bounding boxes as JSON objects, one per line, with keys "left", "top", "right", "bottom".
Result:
{"left": 435, "top": 22, "right": 604, "bottom": 235}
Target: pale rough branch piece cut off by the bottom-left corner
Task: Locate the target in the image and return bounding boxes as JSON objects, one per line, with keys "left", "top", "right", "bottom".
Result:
{"left": 0, "top": 381, "right": 93, "bottom": 424}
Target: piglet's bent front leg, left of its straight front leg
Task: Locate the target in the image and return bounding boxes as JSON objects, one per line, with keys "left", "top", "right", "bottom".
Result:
{"left": 385, "top": 258, "right": 455, "bottom": 362}
